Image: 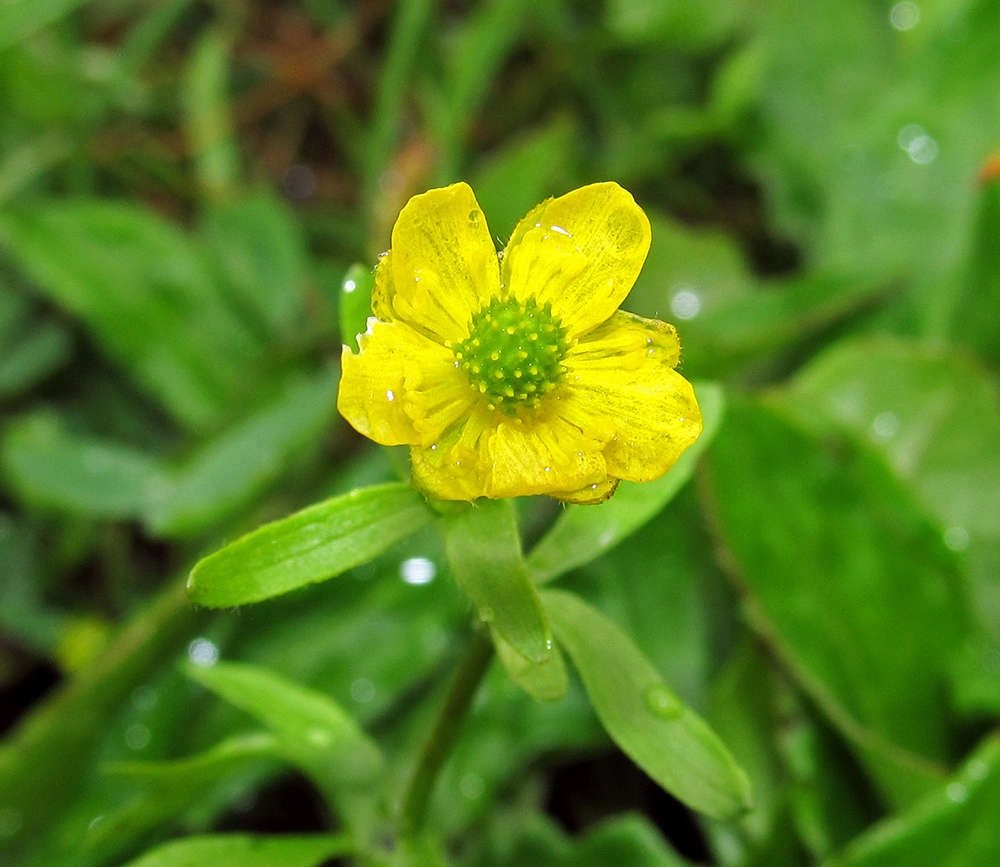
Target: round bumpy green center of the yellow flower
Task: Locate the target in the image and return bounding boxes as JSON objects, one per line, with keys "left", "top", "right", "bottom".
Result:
{"left": 451, "top": 298, "right": 570, "bottom": 415}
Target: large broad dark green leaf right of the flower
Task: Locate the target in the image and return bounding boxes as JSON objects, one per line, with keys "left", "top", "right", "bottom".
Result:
{"left": 708, "top": 404, "right": 968, "bottom": 802}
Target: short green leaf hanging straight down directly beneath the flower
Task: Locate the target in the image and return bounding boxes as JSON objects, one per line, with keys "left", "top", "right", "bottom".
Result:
{"left": 445, "top": 499, "right": 552, "bottom": 664}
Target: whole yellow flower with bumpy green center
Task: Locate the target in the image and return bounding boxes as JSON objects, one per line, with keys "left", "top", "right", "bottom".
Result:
{"left": 337, "top": 183, "right": 701, "bottom": 503}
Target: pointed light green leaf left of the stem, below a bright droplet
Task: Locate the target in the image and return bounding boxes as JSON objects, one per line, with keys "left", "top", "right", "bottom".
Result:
{"left": 187, "top": 663, "right": 384, "bottom": 831}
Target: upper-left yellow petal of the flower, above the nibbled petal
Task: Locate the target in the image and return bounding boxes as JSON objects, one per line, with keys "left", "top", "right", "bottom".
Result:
{"left": 373, "top": 184, "right": 500, "bottom": 344}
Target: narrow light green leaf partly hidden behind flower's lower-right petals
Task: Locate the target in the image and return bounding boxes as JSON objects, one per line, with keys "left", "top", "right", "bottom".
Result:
{"left": 528, "top": 382, "right": 724, "bottom": 583}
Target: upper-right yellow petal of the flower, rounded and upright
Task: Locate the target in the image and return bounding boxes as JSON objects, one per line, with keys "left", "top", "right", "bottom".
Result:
{"left": 500, "top": 183, "right": 650, "bottom": 338}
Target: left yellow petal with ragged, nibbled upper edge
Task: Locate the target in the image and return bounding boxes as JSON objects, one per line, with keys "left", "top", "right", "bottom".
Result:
{"left": 337, "top": 317, "right": 473, "bottom": 446}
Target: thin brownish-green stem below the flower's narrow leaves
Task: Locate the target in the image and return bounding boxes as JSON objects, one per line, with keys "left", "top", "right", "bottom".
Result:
{"left": 400, "top": 630, "right": 493, "bottom": 837}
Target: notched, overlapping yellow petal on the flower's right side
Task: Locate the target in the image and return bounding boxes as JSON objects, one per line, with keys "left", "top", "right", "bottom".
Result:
{"left": 562, "top": 312, "right": 701, "bottom": 482}
